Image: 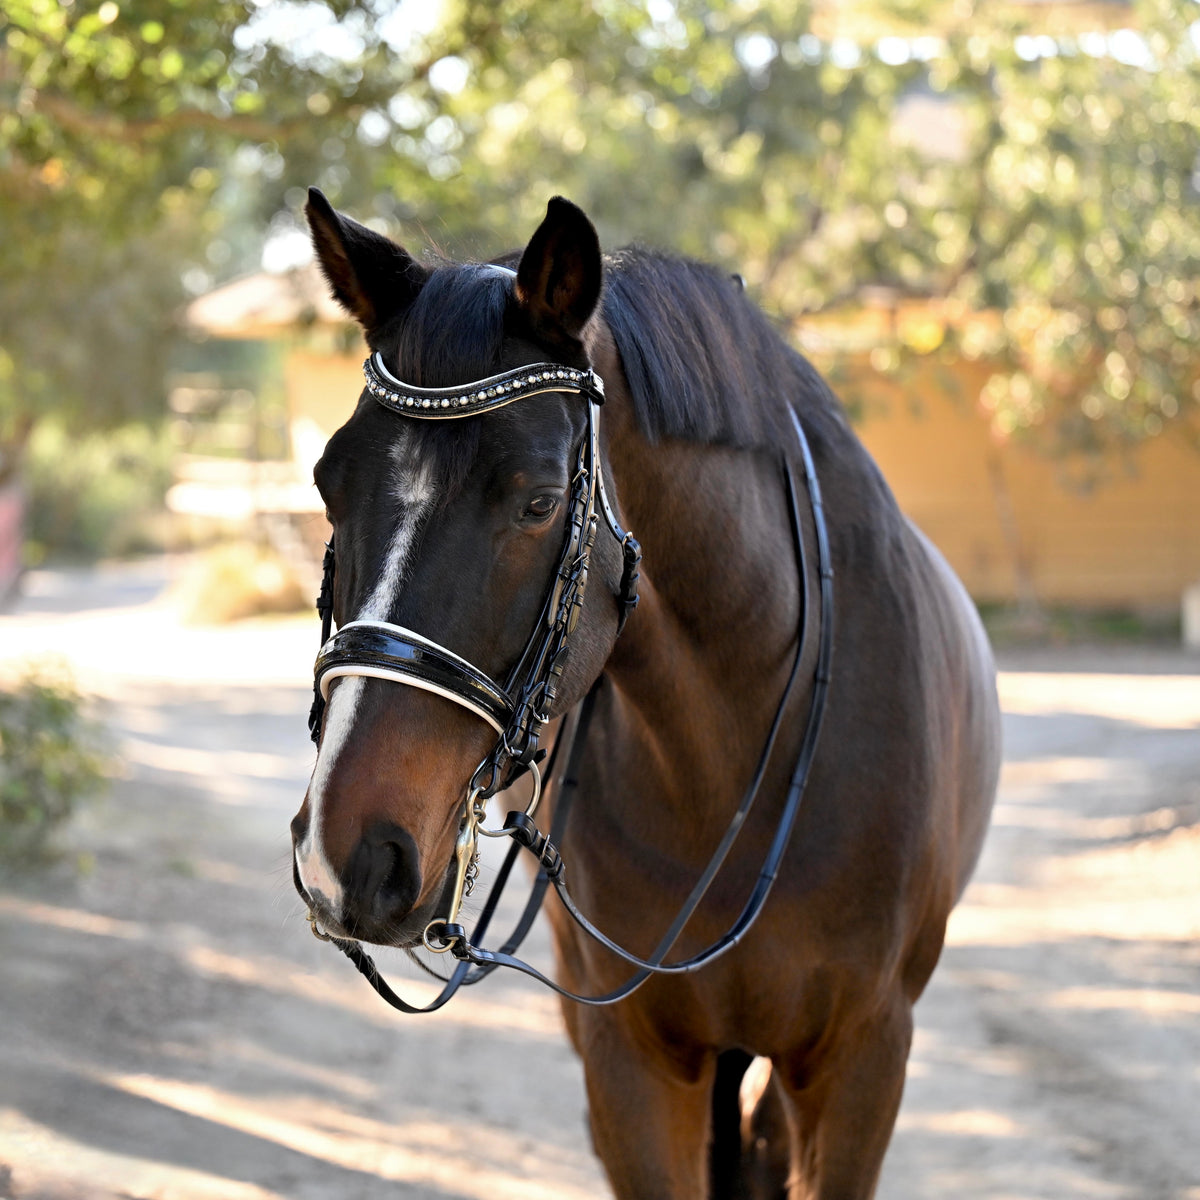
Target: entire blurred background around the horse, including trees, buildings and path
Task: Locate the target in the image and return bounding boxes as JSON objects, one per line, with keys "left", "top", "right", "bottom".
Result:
{"left": 0, "top": 0, "right": 1200, "bottom": 1200}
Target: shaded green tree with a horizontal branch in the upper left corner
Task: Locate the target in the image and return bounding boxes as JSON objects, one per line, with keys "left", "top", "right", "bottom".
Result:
{"left": 0, "top": 0, "right": 398, "bottom": 482}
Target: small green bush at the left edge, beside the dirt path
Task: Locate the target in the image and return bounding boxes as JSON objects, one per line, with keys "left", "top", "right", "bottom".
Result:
{"left": 0, "top": 673, "right": 107, "bottom": 863}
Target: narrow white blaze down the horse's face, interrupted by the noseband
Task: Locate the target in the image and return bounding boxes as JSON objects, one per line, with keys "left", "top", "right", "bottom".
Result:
{"left": 296, "top": 437, "right": 433, "bottom": 911}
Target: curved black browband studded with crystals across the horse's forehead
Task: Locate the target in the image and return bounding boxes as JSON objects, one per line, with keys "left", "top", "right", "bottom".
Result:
{"left": 362, "top": 350, "right": 604, "bottom": 419}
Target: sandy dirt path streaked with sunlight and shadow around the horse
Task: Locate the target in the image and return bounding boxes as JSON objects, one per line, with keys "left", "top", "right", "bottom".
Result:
{"left": 0, "top": 564, "right": 1200, "bottom": 1200}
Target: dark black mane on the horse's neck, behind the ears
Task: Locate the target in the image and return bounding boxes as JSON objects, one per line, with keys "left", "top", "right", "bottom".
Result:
{"left": 604, "top": 246, "right": 842, "bottom": 449}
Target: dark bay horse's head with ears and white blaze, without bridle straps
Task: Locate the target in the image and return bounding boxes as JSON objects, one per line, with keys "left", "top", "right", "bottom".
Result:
{"left": 292, "top": 191, "right": 622, "bottom": 946}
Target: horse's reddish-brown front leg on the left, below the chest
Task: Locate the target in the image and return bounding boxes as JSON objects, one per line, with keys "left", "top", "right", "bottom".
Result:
{"left": 566, "top": 1004, "right": 714, "bottom": 1200}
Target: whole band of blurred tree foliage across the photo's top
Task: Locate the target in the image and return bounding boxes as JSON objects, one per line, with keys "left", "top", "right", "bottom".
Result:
{"left": 0, "top": 0, "right": 1200, "bottom": 468}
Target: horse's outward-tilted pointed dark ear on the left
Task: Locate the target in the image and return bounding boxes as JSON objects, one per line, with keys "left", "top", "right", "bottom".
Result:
{"left": 305, "top": 187, "right": 426, "bottom": 342}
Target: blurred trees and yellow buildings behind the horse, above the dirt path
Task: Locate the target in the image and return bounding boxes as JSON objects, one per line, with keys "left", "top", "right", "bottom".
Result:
{"left": 0, "top": 0, "right": 1200, "bottom": 620}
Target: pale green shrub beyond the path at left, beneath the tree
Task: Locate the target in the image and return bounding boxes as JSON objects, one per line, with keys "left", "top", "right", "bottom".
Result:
{"left": 26, "top": 421, "right": 170, "bottom": 559}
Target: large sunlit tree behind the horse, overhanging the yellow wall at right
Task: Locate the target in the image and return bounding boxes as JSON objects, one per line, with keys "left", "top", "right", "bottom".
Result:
{"left": 392, "top": 0, "right": 1200, "bottom": 463}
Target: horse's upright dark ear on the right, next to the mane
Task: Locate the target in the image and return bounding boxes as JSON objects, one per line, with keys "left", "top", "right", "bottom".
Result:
{"left": 516, "top": 196, "right": 604, "bottom": 343}
